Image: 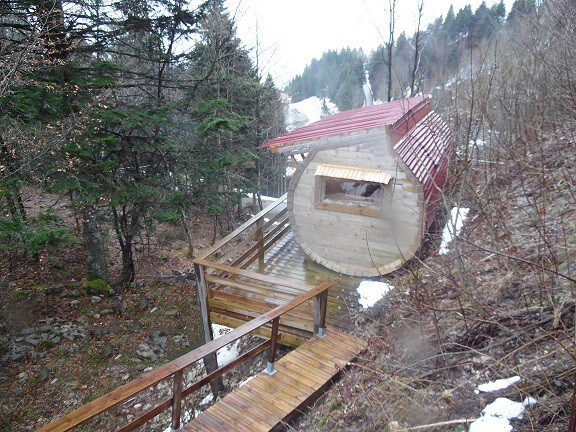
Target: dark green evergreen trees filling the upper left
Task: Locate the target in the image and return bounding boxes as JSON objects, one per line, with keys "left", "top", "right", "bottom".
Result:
{"left": 0, "top": 0, "right": 284, "bottom": 283}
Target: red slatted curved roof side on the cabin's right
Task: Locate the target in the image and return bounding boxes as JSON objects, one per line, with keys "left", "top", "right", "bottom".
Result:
{"left": 394, "top": 112, "right": 452, "bottom": 226}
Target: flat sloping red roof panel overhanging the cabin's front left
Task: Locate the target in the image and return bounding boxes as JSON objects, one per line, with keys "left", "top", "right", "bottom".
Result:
{"left": 262, "top": 95, "right": 430, "bottom": 151}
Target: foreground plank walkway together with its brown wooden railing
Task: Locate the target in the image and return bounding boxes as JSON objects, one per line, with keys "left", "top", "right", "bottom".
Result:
{"left": 39, "top": 283, "right": 366, "bottom": 432}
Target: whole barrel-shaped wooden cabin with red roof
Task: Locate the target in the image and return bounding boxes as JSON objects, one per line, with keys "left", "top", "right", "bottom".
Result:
{"left": 264, "top": 96, "right": 452, "bottom": 276}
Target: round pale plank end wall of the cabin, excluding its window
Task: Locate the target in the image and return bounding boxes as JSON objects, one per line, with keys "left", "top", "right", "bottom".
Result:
{"left": 288, "top": 131, "right": 426, "bottom": 277}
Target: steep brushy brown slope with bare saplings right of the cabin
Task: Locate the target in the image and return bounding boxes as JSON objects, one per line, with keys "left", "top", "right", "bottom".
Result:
{"left": 300, "top": 0, "right": 576, "bottom": 432}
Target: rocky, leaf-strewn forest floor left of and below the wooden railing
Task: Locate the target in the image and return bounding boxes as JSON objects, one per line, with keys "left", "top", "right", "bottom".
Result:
{"left": 0, "top": 197, "right": 294, "bottom": 431}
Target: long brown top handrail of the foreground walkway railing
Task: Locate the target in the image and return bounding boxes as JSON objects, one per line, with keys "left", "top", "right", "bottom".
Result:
{"left": 38, "top": 280, "right": 332, "bottom": 432}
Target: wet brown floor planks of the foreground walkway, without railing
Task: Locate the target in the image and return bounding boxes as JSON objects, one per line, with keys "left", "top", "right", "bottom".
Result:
{"left": 182, "top": 326, "right": 367, "bottom": 432}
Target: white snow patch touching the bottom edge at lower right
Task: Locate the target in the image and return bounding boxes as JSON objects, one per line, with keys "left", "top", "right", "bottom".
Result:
{"left": 470, "top": 397, "right": 537, "bottom": 432}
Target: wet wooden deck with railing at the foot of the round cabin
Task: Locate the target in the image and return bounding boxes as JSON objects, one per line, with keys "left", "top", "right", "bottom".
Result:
{"left": 194, "top": 200, "right": 362, "bottom": 347}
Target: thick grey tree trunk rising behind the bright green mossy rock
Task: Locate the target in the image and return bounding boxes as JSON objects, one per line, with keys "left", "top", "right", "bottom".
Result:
{"left": 82, "top": 206, "right": 108, "bottom": 281}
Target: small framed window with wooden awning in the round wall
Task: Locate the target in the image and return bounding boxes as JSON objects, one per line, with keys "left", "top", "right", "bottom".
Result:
{"left": 315, "top": 165, "right": 392, "bottom": 217}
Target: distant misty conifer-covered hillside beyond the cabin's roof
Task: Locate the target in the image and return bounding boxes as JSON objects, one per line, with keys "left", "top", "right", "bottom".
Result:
{"left": 286, "top": 0, "right": 536, "bottom": 110}
